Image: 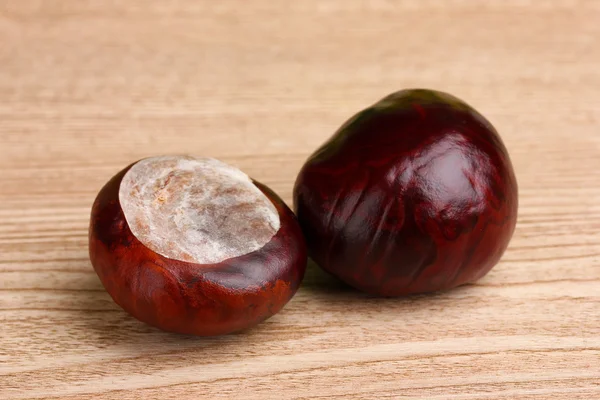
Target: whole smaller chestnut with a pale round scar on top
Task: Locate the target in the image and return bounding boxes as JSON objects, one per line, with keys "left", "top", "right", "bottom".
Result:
{"left": 89, "top": 156, "right": 306, "bottom": 336}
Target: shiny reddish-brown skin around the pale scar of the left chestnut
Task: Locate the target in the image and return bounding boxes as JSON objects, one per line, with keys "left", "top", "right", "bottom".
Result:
{"left": 89, "top": 164, "right": 307, "bottom": 336}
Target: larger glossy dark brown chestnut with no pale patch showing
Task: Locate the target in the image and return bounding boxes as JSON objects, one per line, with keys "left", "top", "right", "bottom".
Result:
{"left": 294, "top": 90, "right": 518, "bottom": 296}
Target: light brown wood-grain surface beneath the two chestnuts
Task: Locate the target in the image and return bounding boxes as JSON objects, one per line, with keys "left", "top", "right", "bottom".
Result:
{"left": 0, "top": 0, "right": 600, "bottom": 400}
